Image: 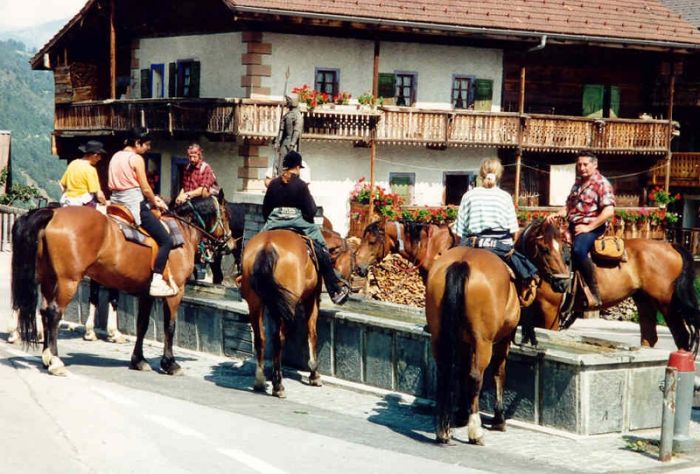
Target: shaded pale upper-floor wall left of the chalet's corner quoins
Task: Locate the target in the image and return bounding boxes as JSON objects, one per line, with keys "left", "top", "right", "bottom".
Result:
{"left": 137, "top": 32, "right": 246, "bottom": 97}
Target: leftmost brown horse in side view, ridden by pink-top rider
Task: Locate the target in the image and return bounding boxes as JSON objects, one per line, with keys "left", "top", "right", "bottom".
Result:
{"left": 12, "top": 194, "right": 232, "bottom": 375}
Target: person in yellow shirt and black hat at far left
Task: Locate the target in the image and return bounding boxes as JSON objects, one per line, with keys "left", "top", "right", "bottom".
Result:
{"left": 59, "top": 140, "right": 107, "bottom": 207}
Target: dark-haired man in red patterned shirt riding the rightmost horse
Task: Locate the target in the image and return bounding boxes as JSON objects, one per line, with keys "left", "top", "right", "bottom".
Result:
{"left": 547, "top": 151, "right": 615, "bottom": 308}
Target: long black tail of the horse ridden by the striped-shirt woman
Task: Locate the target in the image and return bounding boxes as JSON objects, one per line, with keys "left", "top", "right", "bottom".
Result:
{"left": 436, "top": 262, "right": 470, "bottom": 436}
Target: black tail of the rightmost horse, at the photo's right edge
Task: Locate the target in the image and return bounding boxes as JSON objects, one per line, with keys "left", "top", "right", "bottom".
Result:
{"left": 669, "top": 244, "right": 700, "bottom": 355}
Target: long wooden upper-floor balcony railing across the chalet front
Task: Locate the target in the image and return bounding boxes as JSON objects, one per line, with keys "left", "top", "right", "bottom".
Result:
{"left": 55, "top": 99, "right": 669, "bottom": 154}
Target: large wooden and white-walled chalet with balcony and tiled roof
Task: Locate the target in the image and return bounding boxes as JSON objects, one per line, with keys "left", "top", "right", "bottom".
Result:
{"left": 32, "top": 0, "right": 700, "bottom": 235}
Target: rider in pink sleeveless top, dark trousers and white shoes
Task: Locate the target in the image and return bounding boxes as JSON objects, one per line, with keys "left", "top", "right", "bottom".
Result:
{"left": 109, "top": 128, "right": 178, "bottom": 297}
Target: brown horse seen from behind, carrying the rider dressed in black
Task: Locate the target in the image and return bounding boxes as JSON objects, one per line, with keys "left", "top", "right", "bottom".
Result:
{"left": 241, "top": 229, "right": 349, "bottom": 398}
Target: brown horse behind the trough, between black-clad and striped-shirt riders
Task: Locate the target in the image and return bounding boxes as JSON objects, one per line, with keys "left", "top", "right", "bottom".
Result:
{"left": 355, "top": 221, "right": 459, "bottom": 282}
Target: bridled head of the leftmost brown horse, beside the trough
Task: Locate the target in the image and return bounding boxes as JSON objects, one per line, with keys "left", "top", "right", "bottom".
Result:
{"left": 173, "top": 194, "right": 235, "bottom": 253}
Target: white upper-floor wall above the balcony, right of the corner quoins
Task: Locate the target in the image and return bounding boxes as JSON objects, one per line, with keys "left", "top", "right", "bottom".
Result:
{"left": 263, "top": 33, "right": 503, "bottom": 111}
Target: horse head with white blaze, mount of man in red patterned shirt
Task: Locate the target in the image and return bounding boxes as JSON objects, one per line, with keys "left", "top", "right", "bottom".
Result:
{"left": 515, "top": 220, "right": 570, "bottom": 293}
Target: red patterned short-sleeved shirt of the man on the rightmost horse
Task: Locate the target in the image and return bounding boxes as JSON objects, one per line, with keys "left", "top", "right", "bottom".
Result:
{"left": 566, "top": 171, "right": 615, "bottom": 224}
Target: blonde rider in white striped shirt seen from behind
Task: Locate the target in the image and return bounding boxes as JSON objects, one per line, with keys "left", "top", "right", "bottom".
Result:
{"left": 455, "top": 158, "right": 538, "bottom": 304}
